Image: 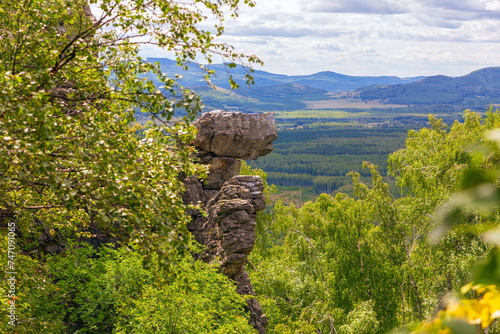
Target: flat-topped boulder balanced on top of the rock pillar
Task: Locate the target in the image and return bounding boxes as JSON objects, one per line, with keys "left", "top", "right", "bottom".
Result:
{"left": 193, "top": 110, "right": 278, "bottom": 160}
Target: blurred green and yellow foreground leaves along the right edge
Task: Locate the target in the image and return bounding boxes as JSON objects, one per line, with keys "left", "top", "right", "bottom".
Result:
{"left": 392, "top": 110, "right": 500, "bottom": 333}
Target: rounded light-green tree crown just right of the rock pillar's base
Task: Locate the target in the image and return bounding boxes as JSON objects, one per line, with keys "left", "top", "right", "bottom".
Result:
{"left": 251, "top": 183, "right": 402, "bottom": 333}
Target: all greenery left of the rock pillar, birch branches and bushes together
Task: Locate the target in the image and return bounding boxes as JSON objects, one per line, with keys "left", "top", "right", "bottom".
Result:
{"left": 0, "top": 0, "right": 260, "bottom": 333}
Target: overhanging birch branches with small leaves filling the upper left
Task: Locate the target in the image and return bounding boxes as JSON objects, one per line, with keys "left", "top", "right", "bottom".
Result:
{"left": 0, "top": 0, "right": 260, "bottom": 260}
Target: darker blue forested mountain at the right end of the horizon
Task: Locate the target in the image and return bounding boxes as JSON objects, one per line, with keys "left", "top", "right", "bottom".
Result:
{"left": 358, "top": 67, "right": 500, "bottom": 106}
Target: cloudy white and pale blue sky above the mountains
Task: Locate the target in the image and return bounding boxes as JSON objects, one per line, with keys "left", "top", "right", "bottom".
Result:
{"left": 138, "top": 0, "right": 500, "bottom": 77}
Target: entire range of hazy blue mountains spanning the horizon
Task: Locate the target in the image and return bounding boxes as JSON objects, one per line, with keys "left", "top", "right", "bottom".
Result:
{"left": 144, "top": 58, "right": 500, "bottom": 112}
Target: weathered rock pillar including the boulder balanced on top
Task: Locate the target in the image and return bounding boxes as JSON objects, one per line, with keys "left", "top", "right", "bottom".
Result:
{"left": 184, "top": 110, "right": 277, "bottom": 334}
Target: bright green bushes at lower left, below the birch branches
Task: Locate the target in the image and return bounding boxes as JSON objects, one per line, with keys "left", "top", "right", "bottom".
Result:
{"left": 0, "top": 239, "right": 254, "bottom": 334}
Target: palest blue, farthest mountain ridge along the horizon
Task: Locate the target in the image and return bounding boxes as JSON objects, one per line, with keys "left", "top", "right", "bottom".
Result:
{"left": 148, "top": 58, "right": 423, "bottom": 92}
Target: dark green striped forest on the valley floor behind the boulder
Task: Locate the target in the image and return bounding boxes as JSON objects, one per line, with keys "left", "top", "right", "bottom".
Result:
{"left": 250, "top": 124, "right": 407, "bottom": 194}
